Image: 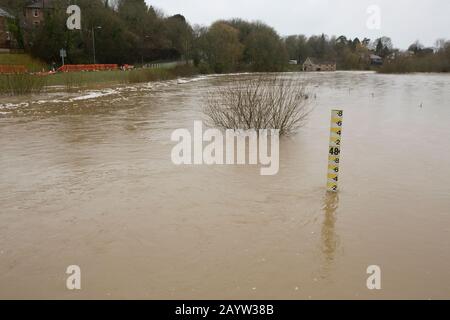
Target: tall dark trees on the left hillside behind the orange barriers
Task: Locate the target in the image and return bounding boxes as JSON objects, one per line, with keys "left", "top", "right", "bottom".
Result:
{"left": 0, "top": 0, "right": 193, "bottom": 64}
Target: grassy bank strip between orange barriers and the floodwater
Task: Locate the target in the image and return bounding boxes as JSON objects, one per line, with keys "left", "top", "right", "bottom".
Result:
{"left": 0, "top": 65, "right": 198, "bottom": 95}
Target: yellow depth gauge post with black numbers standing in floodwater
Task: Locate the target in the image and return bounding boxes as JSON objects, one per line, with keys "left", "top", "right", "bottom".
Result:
{"left": 327, "top": 110, "right": 344, "bottom": 192}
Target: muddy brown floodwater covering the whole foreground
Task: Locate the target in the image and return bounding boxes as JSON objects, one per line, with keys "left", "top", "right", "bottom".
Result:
{"left": 0, "top": 72, "right": 450, "bottom": 299}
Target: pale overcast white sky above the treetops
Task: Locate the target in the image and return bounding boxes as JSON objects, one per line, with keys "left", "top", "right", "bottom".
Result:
{"left": 146, "top": 0, "right": 450, "bottom": 49}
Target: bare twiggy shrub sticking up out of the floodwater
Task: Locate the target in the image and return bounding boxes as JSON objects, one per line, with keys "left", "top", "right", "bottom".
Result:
{"left": 204, "top": 76, "right": 312, "bottom": 135}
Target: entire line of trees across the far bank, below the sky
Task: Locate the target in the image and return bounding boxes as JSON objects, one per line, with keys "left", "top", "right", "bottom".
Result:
{"left": 0, "top": 0, "right": 450, "bottom": 73}
